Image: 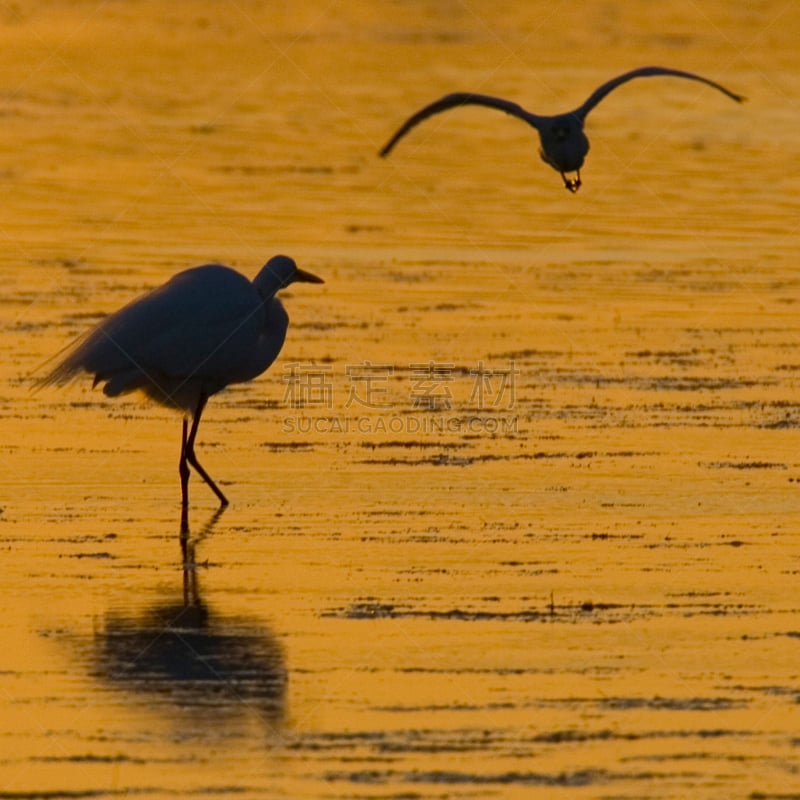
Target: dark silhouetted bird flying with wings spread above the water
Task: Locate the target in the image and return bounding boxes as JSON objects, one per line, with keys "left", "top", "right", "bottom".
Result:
{"left": 380, "top": 67, "right": 744, "bottom": 192}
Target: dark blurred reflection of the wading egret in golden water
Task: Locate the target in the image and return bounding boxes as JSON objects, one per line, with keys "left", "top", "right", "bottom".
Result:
{"left": 94, "top": 509, "right": 288, "bottom": 730}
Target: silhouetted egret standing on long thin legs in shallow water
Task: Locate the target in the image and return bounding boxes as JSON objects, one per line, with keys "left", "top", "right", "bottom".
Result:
{"left": 39, "top": 256, "right": 323, "bottom": 514}
